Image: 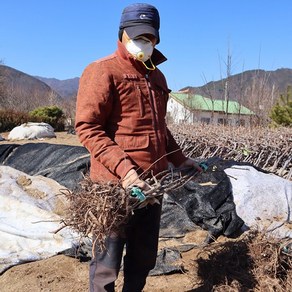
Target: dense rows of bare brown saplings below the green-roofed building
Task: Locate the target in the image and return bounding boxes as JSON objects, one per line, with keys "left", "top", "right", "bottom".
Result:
{"left": 170, "top": 125, "right": 292, "bottom": 180}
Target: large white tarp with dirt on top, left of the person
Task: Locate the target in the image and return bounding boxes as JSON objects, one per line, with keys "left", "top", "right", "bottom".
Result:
{"left": 0, "top": 166, "right": 78, "bottom": 273}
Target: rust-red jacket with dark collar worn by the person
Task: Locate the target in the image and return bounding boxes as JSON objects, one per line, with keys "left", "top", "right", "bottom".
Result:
{"left": 75, "top": 42, "right": 186, "bottom": 182}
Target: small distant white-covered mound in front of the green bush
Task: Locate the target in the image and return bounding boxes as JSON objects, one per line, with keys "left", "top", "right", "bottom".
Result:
{"left": 8, "top": 122, "right": 56, "bottom": 140}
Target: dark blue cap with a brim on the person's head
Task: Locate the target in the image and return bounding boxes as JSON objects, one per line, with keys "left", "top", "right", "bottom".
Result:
{"left": 120, "top": 3, "right": 160, "bottom": 43}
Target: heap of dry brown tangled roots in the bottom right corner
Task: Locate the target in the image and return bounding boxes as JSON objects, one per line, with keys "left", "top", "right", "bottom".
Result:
{"left": 194, "top": 230, "right": 292, "bottom": 292}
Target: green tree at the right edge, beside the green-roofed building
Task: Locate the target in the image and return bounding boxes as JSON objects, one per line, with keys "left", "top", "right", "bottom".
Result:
{"left": 270, "top": 86, "right": 292, "bottom": 127}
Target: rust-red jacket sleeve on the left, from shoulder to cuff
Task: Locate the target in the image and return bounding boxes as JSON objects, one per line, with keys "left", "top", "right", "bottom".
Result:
{"left": 75, "top": 62, "right": 135, "bottom": 179}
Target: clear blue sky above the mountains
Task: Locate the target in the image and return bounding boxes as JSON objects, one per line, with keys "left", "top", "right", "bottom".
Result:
{"left": 0, "top": 0, "right": 292, "bottom": 90}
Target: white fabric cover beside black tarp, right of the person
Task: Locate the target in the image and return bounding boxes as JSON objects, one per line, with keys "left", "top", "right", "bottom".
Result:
{"left": 225, "top": 165, "right": 292, "bottom": 238}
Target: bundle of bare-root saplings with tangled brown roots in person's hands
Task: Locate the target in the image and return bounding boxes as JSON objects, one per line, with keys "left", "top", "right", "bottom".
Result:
{"left": 62, "top": 169, "right": 203, "bottom": 249}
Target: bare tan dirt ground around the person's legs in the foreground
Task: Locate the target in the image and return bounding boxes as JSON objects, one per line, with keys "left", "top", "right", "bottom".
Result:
{"left": 0, "top": 230, "right": 212, "bottom": 292}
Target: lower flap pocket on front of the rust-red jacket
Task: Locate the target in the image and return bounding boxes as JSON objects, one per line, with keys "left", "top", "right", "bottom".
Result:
{"left": 115, "top": 135, "right": 149, "bottom": 151}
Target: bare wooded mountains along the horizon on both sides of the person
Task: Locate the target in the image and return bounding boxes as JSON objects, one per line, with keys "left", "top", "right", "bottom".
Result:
{"left": 0, "top": 65, "right": 292, "bottom": 107}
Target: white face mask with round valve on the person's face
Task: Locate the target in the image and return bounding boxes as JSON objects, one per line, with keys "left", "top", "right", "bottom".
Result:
{"left": 126, "top": 36, "right": 154, "bottom": 62}
